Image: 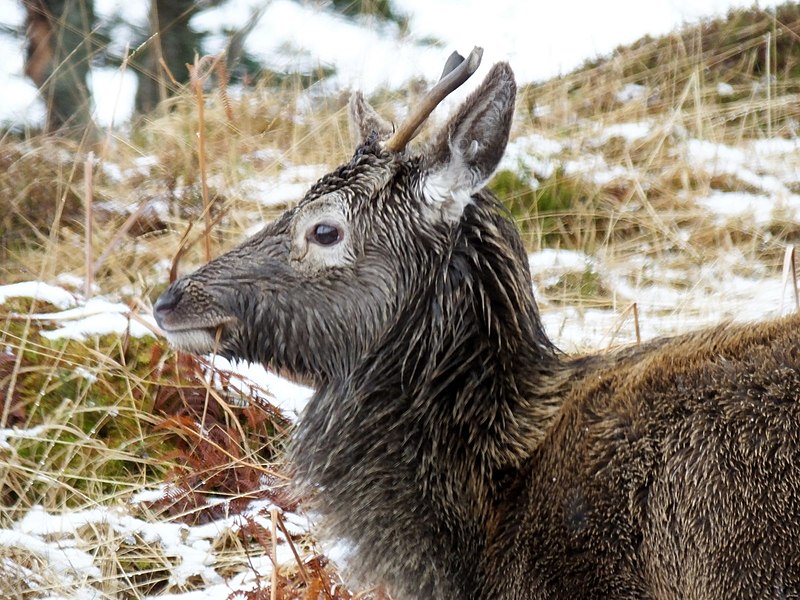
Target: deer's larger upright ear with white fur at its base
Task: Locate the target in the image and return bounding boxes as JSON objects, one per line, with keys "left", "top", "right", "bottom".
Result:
{"left": 423, "top": 63, "right": 517, "bottom": 220}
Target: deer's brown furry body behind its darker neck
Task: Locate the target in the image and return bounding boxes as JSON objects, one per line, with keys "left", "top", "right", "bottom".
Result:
{"left": 486, "top": 316, "right": 800, "bottom": 599}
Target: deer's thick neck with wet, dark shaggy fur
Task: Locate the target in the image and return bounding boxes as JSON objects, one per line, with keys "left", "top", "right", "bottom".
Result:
{"left": 293, "top": 196, "right": 560, "bottom": 597}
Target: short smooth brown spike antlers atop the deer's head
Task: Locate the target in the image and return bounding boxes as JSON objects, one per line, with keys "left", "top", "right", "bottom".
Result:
{"left": 384, "top": 46, "right": 483, "bottom": 152}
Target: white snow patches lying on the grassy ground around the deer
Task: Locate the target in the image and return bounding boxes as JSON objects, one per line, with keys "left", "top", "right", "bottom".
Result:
{"left": 0, "top": 115, "right": 800, "bottom": 600}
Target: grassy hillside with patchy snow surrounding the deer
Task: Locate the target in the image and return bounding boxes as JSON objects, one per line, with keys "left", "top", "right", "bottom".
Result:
{"left": 0, "top": 3, "right": 800, "bottom": 600}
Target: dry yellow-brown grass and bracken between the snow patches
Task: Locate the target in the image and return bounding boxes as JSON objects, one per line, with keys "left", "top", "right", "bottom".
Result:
{"left": 0, "top": 3, "right": 800, "bottom": 598}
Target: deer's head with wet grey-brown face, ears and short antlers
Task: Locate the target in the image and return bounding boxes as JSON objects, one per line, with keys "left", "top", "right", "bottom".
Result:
{"left": 154, "top": 48, "right": 516, "bottom": 381}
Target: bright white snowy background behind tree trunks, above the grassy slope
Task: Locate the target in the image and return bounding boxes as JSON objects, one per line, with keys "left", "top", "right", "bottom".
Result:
{"left": 0, "top": 0, "right": 780, "bottom": 127}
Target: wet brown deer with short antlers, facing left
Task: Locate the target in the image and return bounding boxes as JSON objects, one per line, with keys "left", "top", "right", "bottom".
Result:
{"left": 153, "top": 48, "right": 800, "bottom": 600}
